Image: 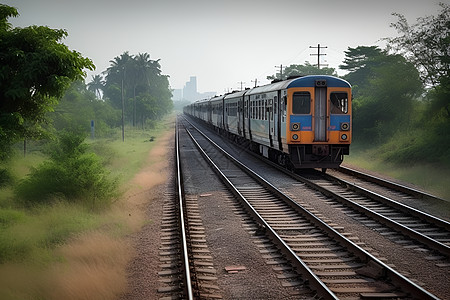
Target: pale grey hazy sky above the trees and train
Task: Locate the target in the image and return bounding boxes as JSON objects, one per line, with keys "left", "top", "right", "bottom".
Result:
{"left": 0, "top": 0, "right": 442, "bottom": 94}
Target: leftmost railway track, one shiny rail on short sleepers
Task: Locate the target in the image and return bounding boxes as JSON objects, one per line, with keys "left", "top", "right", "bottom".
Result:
{"left": 158, "top": 120, "right": 221, "bottom": 300}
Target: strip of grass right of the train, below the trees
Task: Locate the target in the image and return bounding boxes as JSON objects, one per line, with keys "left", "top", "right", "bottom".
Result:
{"left": 344, "top": 144, "right": 450, "bottom": 200}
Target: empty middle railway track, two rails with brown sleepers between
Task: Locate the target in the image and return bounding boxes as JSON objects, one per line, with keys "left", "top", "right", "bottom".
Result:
{"left": 179, "top": 116, "right": 437, "bottom": 299}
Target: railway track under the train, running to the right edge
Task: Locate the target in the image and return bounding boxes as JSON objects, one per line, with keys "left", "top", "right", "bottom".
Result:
{"left": 183, "top": 115, "right": 450, "bottom": 258}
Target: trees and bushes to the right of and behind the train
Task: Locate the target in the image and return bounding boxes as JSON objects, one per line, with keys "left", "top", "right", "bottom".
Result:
{"left": 267, "top": 3, "right": 450, "bottom": 166}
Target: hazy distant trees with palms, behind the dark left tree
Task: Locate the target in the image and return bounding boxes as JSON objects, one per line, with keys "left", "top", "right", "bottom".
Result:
{"left": 49, "top": 52, "right": 173, "bottom": 137}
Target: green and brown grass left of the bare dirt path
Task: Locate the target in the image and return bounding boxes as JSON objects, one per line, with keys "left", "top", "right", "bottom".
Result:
{"left": 0, "top": 117, "right": 173, "bottom": 300}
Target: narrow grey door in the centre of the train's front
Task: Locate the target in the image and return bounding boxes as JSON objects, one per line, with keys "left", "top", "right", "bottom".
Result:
{"left": 314, "top": 80, "right": 327, "bottom": 142}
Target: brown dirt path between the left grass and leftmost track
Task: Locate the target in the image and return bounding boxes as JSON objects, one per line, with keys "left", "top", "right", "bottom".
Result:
{"left": 121, "top": 131, "right": 173, "bottom": 300}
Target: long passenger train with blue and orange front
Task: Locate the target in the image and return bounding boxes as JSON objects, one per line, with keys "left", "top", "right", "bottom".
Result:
{"left": 183, "top": 75, "right": 352, "bottom": 172}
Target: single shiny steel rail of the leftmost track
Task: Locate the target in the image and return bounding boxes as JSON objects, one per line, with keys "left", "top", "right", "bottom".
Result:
{"left": 175, "top": 120, "right": 194, "bottom": 300}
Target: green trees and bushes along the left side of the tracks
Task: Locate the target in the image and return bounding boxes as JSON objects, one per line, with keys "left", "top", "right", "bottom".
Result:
{"left": 0, "top": 4, "right": 173, "bottom": 206}
